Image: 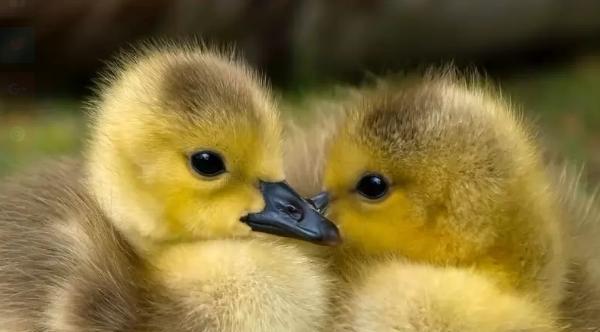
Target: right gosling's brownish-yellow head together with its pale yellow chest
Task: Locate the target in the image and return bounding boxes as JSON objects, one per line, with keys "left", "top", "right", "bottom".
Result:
{"left": 290, "top": 76, "right": 566, "bottom": 331}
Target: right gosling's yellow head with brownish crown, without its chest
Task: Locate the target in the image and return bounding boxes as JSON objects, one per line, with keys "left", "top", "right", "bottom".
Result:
{"left": 324, "top": 77, "right": 559, "bottom": 290}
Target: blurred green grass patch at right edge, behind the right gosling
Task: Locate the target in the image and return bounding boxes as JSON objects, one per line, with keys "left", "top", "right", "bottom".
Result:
{"left": 501, "top": 57, "right": 600, "bottom": 181}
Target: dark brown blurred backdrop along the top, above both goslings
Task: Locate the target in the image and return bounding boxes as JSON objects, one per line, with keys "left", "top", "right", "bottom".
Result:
{"left": 0, "top": 0, "right": 600, "bottom": 96}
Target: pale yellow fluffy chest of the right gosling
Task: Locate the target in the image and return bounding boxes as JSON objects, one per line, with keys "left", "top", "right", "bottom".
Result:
{"left": 333, "top": 259, "right": 559, "bottom": 332}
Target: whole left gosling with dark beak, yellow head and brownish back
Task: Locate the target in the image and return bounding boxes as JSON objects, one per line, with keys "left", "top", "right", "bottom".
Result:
{"left": 0, "top": 45, "right": 338, "bottom": 332}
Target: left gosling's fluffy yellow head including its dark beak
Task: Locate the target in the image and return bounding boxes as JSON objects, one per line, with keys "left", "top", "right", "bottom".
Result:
{"left": 87, "top": 46, "right": 338, "bottom": 250}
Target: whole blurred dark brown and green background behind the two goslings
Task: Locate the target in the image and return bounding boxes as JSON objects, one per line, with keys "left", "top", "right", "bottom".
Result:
{"left": 0, "top": 0, "right": 600, "bottom": 181}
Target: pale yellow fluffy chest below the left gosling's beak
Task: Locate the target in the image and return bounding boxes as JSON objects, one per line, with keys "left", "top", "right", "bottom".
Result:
{"left": 148, "top": 240, "right": 329, "bottom": 331}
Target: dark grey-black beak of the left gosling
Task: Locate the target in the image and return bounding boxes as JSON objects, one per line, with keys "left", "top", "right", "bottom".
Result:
{"left": 241, "top": 181, "right": 341, "bottom": 245}
